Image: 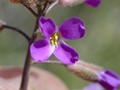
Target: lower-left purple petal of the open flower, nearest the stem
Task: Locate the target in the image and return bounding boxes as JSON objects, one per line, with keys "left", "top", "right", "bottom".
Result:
{"left": 30, "top": 40, "right": 55, "bottom": 62}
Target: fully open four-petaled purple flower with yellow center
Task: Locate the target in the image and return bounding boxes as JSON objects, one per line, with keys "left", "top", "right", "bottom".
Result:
{"left": 30, "top": 17, "right": 85, "bottom": 64}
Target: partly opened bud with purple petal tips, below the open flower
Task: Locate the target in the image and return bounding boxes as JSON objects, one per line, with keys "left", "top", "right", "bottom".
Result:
{"left": 66, "top": 60, "right": 120, "bottom": 90}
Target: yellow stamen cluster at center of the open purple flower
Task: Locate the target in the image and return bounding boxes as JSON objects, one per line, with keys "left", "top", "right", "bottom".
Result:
{"left": 50, "top": 32, "right": 61, "bottom": 47}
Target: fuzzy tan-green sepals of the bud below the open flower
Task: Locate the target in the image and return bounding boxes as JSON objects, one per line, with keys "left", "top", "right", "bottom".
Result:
{"left": 66, "top": 60, "right": 99, "bottom": 81}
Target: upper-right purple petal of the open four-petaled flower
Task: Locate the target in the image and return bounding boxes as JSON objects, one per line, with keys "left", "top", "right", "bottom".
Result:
{"left": 59, "top": 17, "right": 85, "bottom": 40}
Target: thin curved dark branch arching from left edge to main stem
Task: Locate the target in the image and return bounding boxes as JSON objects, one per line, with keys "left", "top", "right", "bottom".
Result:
{"left": 3, "top": 25, "right": 30, "bottom": 42}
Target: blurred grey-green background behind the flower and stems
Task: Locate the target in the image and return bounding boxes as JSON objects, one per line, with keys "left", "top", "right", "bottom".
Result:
{"left": 0, "top": 0, "right": 120, "bottom": 90}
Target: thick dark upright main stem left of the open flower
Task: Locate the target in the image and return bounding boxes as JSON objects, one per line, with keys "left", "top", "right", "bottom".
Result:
{"left": 19, "top": 3, "right": 54, "bottom": 90}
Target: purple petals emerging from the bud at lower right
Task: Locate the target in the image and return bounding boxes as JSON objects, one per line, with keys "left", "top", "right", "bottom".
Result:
{"left": 97, "top": 70, "right": 120, "bottom": 90}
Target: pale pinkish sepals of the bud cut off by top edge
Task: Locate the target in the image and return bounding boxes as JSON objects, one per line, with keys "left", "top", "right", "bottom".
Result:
{"left": 59, "top": 0, "right": 85, "bottom": 6}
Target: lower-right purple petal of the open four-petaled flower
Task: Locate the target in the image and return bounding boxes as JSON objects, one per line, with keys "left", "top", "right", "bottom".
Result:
{"left": 54, "top": 42, "right": 79, "bottom": 64}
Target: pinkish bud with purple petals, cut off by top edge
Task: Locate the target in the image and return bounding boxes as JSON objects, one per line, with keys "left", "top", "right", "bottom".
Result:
{"left": 60, "top": 0, "right": 101, "bottom": 8}
